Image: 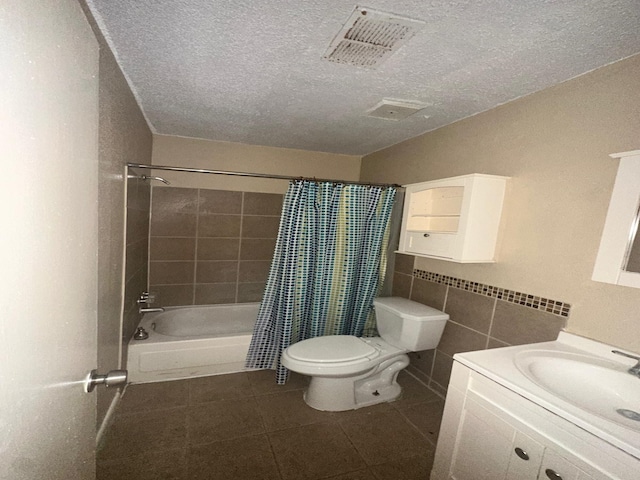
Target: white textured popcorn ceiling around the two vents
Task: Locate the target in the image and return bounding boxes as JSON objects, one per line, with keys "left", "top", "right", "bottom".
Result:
{"left": 87, "top": 0, "right": 640, "bottom": 155}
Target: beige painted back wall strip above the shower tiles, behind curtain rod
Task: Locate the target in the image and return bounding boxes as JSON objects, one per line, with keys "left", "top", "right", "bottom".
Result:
{"left": 153, "top": 135, "right": 360, "bottom": 193}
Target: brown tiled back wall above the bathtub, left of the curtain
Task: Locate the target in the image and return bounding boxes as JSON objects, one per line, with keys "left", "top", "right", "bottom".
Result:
{"left": 149, "top": 187, "right": 283, "bottom": 306}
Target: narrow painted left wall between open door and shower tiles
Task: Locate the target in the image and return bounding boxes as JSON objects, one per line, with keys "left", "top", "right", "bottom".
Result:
{"left": 81, "top": 2, "right": 152, "bottom": 425}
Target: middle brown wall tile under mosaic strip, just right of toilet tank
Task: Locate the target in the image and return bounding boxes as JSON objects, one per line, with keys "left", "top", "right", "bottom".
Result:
{"left": 445, "top": 288, "right": 496, "bottom": 333}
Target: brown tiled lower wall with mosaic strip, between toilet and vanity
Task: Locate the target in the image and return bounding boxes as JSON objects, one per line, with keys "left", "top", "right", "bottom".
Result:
{"left": 392, "top": 254, "right": 569, "bottom": 395}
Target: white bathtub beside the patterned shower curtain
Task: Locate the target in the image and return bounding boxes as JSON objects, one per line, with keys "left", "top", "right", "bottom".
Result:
{"left": 127, "top": 303, "right": 260, "bottom": 383}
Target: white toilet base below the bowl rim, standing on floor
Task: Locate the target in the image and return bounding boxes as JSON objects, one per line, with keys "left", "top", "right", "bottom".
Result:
{"left": 304, "top": 353, "right": 409, "bottom": 412}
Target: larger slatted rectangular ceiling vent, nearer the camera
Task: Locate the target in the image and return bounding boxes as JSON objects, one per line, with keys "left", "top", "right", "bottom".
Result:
{"left": 322, "top": 7, "right": 425, "bottom": 68}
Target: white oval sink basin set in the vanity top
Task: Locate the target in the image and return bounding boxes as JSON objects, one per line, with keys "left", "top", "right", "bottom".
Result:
{"left": 514, "top": 350, "right": 640, "bottom": 432}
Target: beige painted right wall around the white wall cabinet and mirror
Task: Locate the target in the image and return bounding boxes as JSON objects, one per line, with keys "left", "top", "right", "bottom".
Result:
{"left": 361, "top": 56, "right": 640, "bottom": 351}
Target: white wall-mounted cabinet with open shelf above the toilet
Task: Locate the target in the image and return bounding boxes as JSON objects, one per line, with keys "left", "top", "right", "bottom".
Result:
{"left": 398, "top": 173, "right": 508, "bottom": 263}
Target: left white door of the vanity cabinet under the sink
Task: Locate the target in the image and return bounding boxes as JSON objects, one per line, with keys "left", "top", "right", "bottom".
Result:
{"left": 449, "top": 398, "right": 516, "bottom": 480}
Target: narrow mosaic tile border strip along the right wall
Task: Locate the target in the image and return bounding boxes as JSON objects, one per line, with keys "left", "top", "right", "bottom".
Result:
{"left": 413, "top": 268, "right": 571, "bottom": 317}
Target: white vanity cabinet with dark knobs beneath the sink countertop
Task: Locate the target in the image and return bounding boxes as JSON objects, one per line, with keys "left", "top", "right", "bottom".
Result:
{"left": 431, "top": 362, "right": 640, "bottom": 480}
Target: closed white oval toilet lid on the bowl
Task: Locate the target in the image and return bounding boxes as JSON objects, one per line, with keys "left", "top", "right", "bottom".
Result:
{"left": 287, "top": 335, "right": 379, "bottom": 364}
